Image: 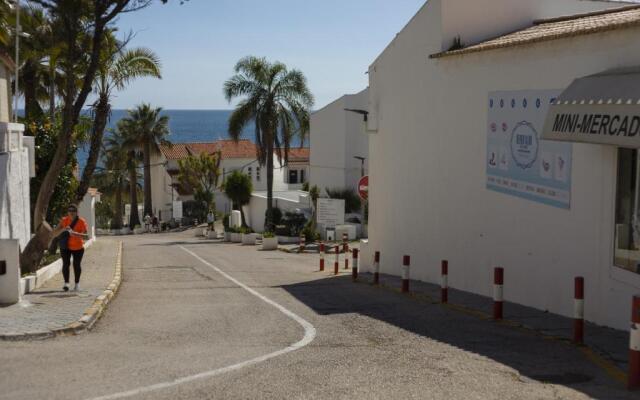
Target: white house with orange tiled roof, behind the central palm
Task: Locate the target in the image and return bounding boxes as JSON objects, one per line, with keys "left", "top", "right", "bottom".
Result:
{"left": 151, "top": 140, "right": 309, "bottom": 222}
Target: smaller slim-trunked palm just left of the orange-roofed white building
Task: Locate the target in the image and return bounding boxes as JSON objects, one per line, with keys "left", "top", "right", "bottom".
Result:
{"left": 123, "top": 104, "right": 170, "bottom": 215}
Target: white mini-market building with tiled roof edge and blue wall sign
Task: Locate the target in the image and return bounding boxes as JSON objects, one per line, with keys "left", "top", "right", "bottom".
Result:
{"left": 368, "top": 0, "right": 640, "bottom": 329}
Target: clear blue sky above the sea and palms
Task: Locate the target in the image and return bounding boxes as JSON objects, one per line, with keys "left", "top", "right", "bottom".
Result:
{"left": 113, "top": 0, "right": 425, "bottom": 109}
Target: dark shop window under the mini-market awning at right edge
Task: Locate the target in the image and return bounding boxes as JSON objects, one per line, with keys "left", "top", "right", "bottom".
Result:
{"left": 614, "top": 149, "right": 640, "bottom": 273}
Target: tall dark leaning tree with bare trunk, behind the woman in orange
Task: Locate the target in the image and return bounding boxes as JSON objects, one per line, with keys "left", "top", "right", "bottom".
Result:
{"left": 20, "top": 0, "right": 160, "bottom": 272}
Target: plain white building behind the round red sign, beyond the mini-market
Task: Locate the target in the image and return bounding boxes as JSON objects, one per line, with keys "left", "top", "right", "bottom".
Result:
{"left": 309, "top": 89, "right": 369, "bottom": 195}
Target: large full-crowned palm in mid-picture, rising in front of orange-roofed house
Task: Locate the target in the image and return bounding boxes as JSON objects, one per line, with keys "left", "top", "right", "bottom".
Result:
{"left": 224, "top": 57, "right": 313, "bottom": 231}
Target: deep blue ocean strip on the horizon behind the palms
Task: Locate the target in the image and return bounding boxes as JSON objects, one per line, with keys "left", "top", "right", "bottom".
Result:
{"left": 77, "top": 110, "right": 299, "bottom": 171}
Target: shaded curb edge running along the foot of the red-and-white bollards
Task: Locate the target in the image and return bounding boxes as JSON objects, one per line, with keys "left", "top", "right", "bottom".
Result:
{"left": 357, "top": 281, "right": 627, "bottom": 384}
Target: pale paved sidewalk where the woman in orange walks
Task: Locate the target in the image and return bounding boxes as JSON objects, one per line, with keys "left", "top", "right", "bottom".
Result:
{"left": 0, "top": 237, "right": 119, "bottom": 340}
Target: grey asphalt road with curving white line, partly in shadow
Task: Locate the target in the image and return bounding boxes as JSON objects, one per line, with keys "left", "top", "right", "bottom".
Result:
{"left": 0, "top": 232, "right": 639, "bottom": 400}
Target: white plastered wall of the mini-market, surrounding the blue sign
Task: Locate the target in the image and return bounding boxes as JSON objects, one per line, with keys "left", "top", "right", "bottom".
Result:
{"left": 369, "top": 0, "right": 640, "bottom": 329}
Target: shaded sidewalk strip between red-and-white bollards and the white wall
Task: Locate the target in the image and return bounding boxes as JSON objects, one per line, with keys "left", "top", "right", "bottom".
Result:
{"left": 358, "top": 272, "right": 629, "bottom": 381}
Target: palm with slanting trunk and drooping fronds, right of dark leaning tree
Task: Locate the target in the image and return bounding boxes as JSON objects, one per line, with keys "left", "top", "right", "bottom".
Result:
{"left": 76, "top": 34, "right": 161, "bottom": 203}
